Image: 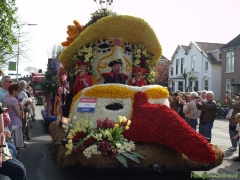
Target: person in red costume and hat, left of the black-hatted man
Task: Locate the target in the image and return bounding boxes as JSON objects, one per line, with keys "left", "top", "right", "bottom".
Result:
{"left": 73, "top": 62, "right": 93, "bottom": 96}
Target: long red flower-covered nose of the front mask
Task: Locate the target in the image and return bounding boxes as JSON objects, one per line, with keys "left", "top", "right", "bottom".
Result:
{"left": 124, "top": 92, "right": 216, "bottom": 163}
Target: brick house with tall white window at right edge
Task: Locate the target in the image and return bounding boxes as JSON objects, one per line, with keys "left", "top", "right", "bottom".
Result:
{"left": 221, "top": 34, "right": 240, "bottom": 97}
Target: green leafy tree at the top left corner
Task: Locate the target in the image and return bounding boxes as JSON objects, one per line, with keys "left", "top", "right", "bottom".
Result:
{"left": 0, "top": 0, "right": 18, "bottom": 64}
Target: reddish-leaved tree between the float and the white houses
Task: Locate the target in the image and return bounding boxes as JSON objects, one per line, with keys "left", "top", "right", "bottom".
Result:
{"left": 155, "top": 63, "right": 169, "bottom": 86}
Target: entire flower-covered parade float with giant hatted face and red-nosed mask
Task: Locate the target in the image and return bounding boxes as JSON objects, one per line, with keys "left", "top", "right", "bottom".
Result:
{"left": 49, "top": 1, "right": 224, "bottom": 170}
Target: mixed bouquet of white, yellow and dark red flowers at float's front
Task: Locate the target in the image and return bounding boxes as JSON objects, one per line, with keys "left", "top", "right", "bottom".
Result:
{"left": 62, "top": 116, "right": 143, "bottom": 167}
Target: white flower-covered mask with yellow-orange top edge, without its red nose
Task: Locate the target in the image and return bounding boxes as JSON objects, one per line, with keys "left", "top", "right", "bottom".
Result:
{"left": 69, "top": 84, "right": 169, "bottom": 124}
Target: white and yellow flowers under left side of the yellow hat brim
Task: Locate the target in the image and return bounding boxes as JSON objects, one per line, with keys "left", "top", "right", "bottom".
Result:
{"left": 65, "top": 43, "right": 97, "bottom": 76}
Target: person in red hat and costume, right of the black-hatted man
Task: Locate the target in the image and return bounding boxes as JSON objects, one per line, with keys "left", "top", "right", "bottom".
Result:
{"left": 130, "top": 67, "right": 147, "bottom": 87}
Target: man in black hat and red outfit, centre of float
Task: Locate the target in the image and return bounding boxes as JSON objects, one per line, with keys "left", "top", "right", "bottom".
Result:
{"left": 102, "top": 59, "right": 128, "bottom": 84}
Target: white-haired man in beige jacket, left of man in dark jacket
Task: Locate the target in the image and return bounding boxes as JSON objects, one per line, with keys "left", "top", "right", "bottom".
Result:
{"left": 183, "top": 92, "right": 200, "bottom": 131}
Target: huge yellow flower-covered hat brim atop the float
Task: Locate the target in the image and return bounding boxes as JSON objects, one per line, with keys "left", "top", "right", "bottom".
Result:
{"left": 59, "top": 15, "right": 162, "bottom": 67}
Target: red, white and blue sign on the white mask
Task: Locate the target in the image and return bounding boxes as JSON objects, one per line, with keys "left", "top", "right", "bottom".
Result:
{"left": 77, "top": 98, "right": 97, "bottom": 112}
